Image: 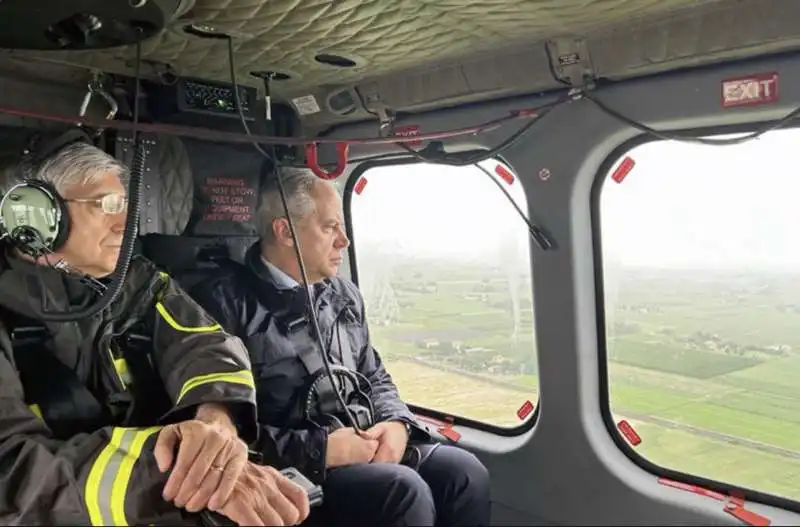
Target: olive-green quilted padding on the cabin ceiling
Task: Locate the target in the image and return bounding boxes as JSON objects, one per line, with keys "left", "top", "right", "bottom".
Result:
{"left": 10, "top": 0, "right": 733, "bottom": 95}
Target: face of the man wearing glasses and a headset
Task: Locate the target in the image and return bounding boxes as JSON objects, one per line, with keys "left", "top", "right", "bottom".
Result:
{"left": 49, "top": 173, "right": 127, "bottom": 278}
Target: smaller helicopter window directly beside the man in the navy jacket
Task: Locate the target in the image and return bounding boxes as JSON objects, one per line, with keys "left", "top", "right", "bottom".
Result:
{"left": 349, "top": 160, "right": 538, "bottom": 428}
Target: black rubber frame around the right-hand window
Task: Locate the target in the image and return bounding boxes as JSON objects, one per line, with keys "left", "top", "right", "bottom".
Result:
{"left": 589, "top": 121, "right": 800, "bottom": 513}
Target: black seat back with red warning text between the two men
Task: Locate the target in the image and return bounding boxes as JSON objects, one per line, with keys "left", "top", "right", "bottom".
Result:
{"left": 117, "top": 131, "right": 263, "bottom": 289}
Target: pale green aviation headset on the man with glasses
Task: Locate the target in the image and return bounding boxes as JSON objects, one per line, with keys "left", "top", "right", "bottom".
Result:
{"left": 0, "top": 129, "right": 94, "bottom": 257}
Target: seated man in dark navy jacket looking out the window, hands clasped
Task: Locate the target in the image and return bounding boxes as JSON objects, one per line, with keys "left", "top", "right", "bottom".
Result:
{"left": 193, "top": 172, "right": 490, "bottom": 527}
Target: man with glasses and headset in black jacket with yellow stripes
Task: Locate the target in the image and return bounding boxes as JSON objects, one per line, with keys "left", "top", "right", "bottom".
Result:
{"left": 0, "top": 134, "right": 308, "bottom": 525}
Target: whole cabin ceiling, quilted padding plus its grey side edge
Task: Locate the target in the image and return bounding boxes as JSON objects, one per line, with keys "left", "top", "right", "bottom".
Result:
{"left": 0, "top": 0, "right": 800, "bottom": 124}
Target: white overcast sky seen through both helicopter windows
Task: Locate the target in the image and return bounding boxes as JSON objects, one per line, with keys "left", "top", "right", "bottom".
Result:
{"left": 352, "top": 130, "right": 800, "bottom": 268}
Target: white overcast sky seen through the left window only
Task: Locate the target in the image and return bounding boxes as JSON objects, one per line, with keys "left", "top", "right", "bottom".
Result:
{"left": 351, "top": 157, "right": 528, "bottom": 265}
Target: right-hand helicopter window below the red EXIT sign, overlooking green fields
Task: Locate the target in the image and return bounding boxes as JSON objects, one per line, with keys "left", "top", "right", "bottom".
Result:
{"left": 598, "top": 130, "right": 800, "bottom": 500}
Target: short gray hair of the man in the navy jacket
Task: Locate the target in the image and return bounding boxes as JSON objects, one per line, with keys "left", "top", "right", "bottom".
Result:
{"left": 256, "top": 168, "right": 324, "bottom": 243}
